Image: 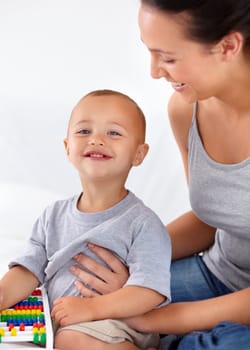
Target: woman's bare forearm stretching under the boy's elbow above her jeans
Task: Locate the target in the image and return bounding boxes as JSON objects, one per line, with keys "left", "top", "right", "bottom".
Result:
{"left": 126, "top": 288, "right": 250, "bottom": 334}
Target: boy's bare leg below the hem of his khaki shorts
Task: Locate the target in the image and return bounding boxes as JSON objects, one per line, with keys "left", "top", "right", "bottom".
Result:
{"left": 55, "top": 330, "right": 140, "bottom": 350}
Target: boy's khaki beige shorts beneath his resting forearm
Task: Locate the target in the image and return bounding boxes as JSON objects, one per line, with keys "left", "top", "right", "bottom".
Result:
{"left": 57, "top": 319, "right": 160, "bottom": 349}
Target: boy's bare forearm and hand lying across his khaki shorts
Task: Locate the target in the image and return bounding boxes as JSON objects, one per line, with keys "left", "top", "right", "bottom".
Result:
{"left": 51, "top": 286, "right": 165, "bottom": 326}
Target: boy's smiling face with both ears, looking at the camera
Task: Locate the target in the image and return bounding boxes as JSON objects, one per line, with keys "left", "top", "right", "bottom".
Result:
{"left": 64, "top": 95, "right": 148, "bottom": 182}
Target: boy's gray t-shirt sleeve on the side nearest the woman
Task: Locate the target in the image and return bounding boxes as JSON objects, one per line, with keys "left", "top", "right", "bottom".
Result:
{"left": 126, "top": 212, "right": 171, "bottom": 305}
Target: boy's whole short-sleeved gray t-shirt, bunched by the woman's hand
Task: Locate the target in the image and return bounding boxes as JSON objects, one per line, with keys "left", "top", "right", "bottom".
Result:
{"left": 9, "top": 192, "right": 171, "bottom": 305}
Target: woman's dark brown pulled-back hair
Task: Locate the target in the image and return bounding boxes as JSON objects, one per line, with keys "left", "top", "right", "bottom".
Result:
{"left": 141, "top": 0, "right": 250, "bottom": 48}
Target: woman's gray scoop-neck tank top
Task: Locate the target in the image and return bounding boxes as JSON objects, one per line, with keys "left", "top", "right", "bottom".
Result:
{"left": 189, "top": 104, "right": 250, "bottom": 291}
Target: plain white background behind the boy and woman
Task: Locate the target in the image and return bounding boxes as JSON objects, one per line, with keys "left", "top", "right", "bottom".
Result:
{"left": 0, "top": 0, "right": 189, "bottom": 273}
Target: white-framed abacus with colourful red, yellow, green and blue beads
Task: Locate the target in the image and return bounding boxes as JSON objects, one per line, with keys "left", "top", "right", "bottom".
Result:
{"left": 0, "top": 288, "right": 53, "bottom": 349}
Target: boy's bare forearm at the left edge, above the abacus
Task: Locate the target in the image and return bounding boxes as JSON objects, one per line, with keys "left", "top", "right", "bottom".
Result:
{"left": 0, "top": 266, "right": 39, "bottom": 310}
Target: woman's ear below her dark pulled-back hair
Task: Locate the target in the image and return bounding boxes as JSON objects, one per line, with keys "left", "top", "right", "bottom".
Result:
{"left": 216, "top": 32, "right": 244, "bottom": 61}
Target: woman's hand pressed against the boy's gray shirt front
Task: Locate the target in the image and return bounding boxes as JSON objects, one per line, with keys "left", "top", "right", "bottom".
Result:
{"left": 70, "top": 243, "right": 129, "bottom": 297}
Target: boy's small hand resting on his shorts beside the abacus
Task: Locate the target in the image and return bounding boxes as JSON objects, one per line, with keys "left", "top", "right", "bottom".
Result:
{"left": 51, "top": 296, "right": 94, "bottom": 326}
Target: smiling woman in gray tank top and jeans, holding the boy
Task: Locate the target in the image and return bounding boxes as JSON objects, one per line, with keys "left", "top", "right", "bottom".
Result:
{"left": 68, "top": 0, "right": 250, "bottom": 350}
